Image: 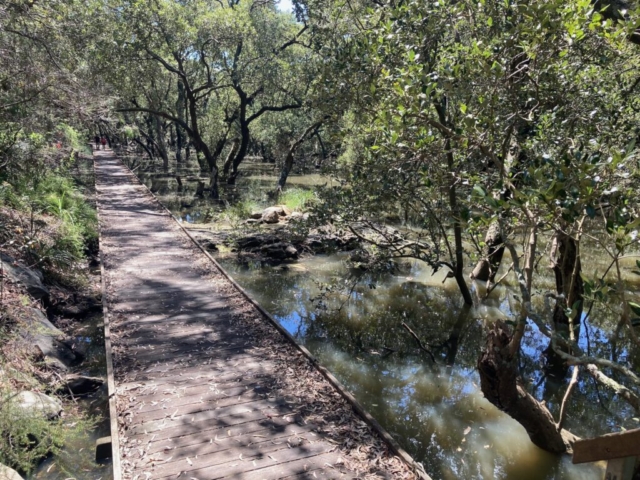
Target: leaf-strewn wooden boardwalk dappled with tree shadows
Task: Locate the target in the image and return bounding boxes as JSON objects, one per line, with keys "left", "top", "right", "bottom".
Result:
{"left": 96, "top": 152, "right": 414, "bottom": 480}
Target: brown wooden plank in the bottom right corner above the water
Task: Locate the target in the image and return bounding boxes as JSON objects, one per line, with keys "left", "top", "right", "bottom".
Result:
{"left": 573, "top": 428, "right": 640, "bottom": 463}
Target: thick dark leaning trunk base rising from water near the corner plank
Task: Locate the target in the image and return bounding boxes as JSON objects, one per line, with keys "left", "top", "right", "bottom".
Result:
{"left": 478, "top": 320, "right": 576, "bottom": 453}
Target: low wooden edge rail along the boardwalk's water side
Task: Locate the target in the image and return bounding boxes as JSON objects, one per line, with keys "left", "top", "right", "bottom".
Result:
{"left": 114, "top": 151, "right": 432, "bottom": 480}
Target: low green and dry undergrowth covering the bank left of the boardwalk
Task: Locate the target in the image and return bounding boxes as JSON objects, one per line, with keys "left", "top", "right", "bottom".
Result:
{"left": 0, "top": 124, "right": 98, "bottom": 476}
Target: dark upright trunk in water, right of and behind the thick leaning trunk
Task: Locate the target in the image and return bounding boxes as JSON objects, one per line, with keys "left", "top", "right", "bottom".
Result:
{"left": 545, "top": 232, "right": 584, "bottom": 378}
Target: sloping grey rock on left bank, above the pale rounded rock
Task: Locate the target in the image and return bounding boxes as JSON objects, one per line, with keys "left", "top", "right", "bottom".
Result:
{"left": 20, "top": 308, "right": 76, "bottom": 371}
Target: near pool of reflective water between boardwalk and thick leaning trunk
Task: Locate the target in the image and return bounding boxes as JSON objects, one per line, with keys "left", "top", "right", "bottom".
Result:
{"left": 221, "top": 255, "right": 602, "bottom": 480}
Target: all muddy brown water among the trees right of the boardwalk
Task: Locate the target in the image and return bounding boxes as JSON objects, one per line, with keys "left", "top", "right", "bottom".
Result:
{"left": 121, "top": 156, "right": 640, "bottom": 480}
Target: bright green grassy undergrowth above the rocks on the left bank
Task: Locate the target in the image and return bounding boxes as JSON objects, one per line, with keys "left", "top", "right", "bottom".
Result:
{"left": 0, "top": 131, "right": 98, "bottom": 274}
